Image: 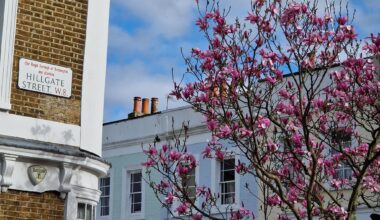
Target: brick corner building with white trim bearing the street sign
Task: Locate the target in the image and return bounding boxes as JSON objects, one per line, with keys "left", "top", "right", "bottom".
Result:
{"left": 0, "top": 0, "right": 110, "bottom": 220}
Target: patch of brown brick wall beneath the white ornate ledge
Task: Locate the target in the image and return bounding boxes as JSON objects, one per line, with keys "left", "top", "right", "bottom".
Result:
{"left": 0, "top": 190, "right": 65, "bottom": 220}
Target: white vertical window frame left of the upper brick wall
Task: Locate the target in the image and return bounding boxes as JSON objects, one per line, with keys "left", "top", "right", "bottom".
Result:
{"left": 0, "top": 0, "right": 18, "bottom": 111}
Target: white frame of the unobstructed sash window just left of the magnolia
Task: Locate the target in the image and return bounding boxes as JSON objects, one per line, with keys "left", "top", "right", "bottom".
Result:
{"left": 121, "top": 165, "right": 146, "bottom": 220}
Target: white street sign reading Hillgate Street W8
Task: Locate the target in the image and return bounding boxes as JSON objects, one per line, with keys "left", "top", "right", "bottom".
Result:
{"left": 18, "top": 58, "right": 73, "bottom": 98}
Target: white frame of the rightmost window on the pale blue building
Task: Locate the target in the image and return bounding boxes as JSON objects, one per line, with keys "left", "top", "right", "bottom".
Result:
{"left": 211, "top": 148, "right": 241, "bottom": 214}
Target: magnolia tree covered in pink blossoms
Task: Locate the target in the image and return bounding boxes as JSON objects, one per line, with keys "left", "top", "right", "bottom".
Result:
{"left": 145, "top": 0, "right": 380, "bottom": 219}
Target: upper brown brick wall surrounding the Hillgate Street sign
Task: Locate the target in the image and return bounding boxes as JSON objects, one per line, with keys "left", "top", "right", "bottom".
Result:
{"left": 10, "top": 0, "right": 87, "bottom": 125}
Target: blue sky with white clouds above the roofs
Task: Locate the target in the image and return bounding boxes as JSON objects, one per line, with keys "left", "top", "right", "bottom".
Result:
{"left": 104, "top": 0, "right": 380, "bottom": 122}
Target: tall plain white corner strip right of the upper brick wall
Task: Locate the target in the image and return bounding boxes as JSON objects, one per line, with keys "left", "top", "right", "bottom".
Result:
{"left": 80, "top": 0, "right": 110, "bottom": 155}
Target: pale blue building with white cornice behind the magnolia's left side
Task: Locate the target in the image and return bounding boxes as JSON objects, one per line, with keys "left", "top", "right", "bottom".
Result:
{"left": 98, "top": 98, "right": 258, "bottom": 220}
